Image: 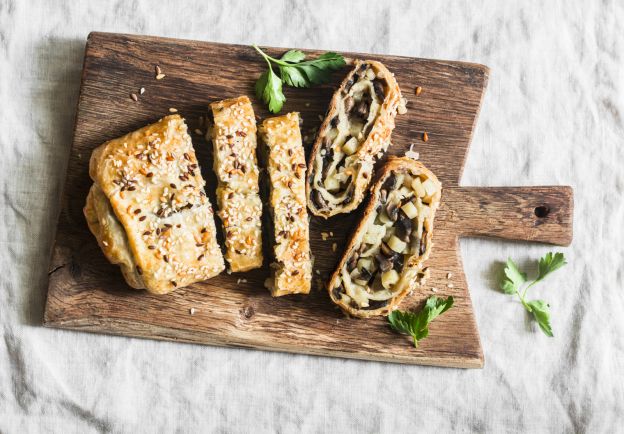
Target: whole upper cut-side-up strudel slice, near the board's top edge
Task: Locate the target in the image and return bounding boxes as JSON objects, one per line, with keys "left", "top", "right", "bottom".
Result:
{"left": 306, "top": 60, "right": 401, "bottom": 218}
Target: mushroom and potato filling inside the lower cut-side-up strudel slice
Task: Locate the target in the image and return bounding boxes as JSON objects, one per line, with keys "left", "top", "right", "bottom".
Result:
{"left": 332, "top": 173, "right": 437, "bottom": 309}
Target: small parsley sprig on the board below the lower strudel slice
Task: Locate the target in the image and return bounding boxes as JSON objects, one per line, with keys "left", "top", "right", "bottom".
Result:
{"left": 388, "top": 295, "right": 453, "bottom": 347}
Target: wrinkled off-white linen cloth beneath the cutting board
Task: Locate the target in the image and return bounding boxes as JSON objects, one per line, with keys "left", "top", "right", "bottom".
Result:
{"left": 0, "top": 0, "right": 624, "bottom": 433}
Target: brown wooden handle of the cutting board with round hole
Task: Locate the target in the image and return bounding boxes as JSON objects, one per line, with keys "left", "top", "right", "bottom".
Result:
{"left": 442, "top": 186, "right": 574, "bottom": 246}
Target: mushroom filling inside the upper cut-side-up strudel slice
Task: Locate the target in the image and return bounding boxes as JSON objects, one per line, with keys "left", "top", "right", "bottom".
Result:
{"left": 311, "top": 63, "right": 386, "bottom": 210}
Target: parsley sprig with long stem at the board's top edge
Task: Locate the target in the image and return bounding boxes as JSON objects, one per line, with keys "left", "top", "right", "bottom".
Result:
{"left": 253, "top": 45, "right": 346, "bottom": 113}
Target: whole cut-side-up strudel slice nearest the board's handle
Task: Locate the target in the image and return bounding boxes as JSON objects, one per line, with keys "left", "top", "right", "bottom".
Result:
{"left": 327, "top": 157, "right": 442, "bottom": 318}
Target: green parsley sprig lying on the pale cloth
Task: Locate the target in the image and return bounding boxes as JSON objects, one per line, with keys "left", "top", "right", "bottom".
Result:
{"left": 501, "top": 252, "right": 567, "bottom": 337}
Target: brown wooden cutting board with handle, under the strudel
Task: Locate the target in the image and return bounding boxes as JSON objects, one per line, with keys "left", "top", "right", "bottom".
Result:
{"left": 44, "top": 33, "right": 573, "bottom": 367}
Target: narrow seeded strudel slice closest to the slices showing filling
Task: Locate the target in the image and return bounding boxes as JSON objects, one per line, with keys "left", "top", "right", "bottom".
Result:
{"left": 260, "top": 113, "right": 312, "bottom": 297}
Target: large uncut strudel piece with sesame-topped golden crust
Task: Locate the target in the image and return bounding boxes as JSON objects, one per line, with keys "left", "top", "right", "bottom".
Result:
{"left": 85, "top": 115, "right": 224, "bottom": 294}
